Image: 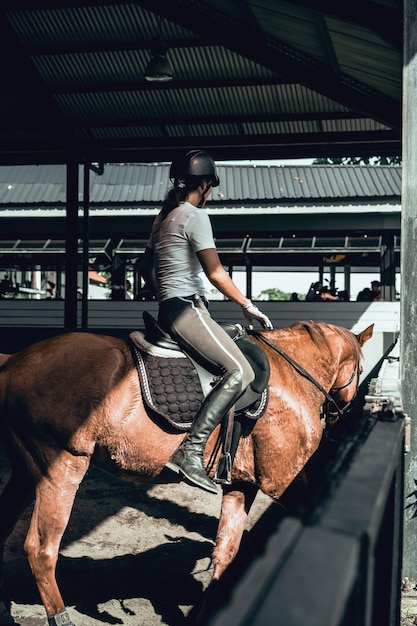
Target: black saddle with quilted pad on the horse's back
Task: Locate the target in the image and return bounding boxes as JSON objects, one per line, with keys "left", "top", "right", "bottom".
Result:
{"left": 129, "top": 311, "right": 270, "bottom": 431}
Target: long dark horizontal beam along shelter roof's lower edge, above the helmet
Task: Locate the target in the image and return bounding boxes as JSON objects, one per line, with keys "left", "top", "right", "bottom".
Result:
{"left": 0, "top": 131, "right": 402, "bottom": 165}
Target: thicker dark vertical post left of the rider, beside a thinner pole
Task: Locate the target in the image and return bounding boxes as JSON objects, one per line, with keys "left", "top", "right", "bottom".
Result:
{"left": 64, "top": 162, "right": 78, "bottom": 329}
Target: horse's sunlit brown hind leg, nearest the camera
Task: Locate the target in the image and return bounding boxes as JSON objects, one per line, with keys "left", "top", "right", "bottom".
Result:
{"left": 25, "top": 452, "right": 90, "bottom": 626}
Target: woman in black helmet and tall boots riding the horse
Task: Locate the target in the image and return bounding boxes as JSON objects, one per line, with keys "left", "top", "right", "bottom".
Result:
{"left": 141, "top": 150, "right": 272, "bottom": 493}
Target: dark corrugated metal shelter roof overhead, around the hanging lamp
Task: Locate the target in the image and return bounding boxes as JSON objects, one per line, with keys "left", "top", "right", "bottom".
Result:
{"left": 0, "top": 0, "right": 403, "bottom": 165}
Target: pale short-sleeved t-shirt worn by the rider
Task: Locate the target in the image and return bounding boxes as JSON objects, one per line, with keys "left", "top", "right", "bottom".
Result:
{"left": 147, "top": 202, "right": 216, "bottom": 302}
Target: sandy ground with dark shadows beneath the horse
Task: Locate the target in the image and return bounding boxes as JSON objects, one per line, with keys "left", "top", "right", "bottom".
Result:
{"left": 0, "top": 442, "right": 271, "bottom": 626}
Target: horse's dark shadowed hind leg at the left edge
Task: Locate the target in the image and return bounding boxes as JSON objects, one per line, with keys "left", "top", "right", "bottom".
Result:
{"left": 0, "top": 468, "right": 34, "bottom": 624}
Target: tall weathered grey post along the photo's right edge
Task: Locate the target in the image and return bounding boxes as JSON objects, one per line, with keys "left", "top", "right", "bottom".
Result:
{"left": 400, "top": 0, "right": 417, "bottom": 578}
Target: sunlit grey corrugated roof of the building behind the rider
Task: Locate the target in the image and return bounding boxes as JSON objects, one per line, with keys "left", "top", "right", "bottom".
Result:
{"left": 0, "top": 163, "right": 401, "bottom": 210}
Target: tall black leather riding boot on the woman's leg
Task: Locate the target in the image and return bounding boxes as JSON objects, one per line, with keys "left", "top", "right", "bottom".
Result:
{"left": 166, "top": 370, "right": 242, "bottom": 493}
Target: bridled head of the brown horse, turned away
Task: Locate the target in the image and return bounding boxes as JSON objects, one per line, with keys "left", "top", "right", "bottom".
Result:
{"left": 326, "top": 324, "right": 374, "bottom": 425}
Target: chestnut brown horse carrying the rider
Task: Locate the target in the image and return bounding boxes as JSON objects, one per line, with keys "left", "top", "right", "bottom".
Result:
{"left": 0, "top": 322, "right": 373, "bottom": 626}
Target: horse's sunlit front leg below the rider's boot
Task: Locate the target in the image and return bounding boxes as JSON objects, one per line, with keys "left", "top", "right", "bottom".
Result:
{"left": 213, "top": 483, "right": 258, "bottom": 581}
